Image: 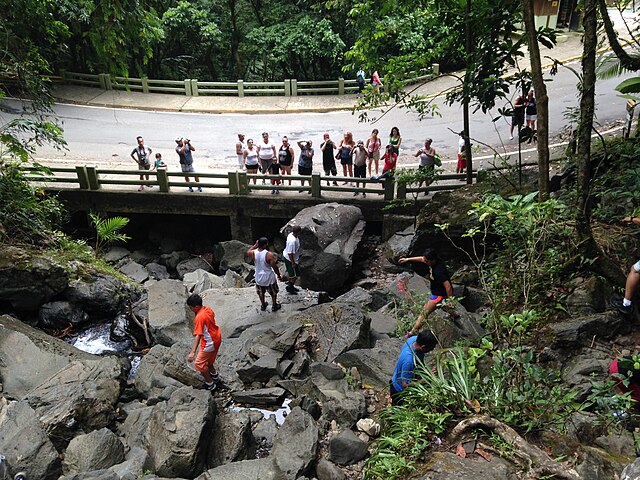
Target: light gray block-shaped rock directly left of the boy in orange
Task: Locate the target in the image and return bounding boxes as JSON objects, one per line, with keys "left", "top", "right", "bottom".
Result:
{"left": 148, "top": 280, "right": 193, "bottom": 346}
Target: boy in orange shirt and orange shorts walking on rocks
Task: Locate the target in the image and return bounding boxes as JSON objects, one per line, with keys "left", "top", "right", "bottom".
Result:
{"left": 187, "top": 293, "right": 222, "bottom": 390}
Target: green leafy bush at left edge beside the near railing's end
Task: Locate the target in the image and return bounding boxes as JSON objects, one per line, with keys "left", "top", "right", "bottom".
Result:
{"left": 0, "top": 159, "right": 66, "bottom": 244}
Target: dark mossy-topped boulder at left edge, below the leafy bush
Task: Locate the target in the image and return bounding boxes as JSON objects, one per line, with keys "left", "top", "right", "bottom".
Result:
{"left": 0, "top": 247, "right": 69, "bottom": 312}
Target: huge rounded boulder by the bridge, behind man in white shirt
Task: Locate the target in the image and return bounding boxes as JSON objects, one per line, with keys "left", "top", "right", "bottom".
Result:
{"left": 281, "top": 203, "right": 365, "bottom": 292}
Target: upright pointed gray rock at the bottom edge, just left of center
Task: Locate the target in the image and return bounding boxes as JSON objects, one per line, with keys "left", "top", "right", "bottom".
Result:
{"left": 271, "top": 407, "right": 318, "bottom": 480}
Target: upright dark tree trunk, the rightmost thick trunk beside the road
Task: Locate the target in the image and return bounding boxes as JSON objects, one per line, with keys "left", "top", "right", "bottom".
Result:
{"left": 575, "top": 0, "right": 597, "bottom": 244}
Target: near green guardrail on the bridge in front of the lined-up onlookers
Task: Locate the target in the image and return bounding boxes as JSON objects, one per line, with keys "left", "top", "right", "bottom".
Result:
{"left": 24, "top": 165, "right": 470, "bottom": 201}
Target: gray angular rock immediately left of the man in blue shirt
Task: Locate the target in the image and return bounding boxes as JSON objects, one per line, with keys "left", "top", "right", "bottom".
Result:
{"left": 335, "top": 338, "right": 403, "bottom": 388}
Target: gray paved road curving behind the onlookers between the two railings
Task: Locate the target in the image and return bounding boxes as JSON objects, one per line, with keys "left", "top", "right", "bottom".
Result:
{"left": 15, "top": 65, "right": 631, "bottom": 170}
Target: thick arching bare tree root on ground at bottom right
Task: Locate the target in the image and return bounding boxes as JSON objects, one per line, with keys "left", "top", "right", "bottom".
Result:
{"left": 451, "top": 415, "right": 580, "bottom": 480}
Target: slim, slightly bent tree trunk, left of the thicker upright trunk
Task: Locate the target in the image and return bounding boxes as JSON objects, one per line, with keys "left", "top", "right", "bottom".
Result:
{"left": 522, "top": 0, "right": 549, "bottom": 200}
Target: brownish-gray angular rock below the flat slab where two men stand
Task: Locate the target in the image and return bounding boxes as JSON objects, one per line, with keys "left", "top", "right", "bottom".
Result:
{"left": 294, "top": 302, "right": 371, "bottom": 362}
